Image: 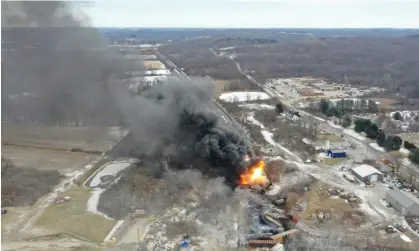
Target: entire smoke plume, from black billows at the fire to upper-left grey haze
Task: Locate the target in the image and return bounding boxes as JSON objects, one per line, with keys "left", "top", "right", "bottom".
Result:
{"left": 2, "top": 1, "right": 251, "bottom": 182}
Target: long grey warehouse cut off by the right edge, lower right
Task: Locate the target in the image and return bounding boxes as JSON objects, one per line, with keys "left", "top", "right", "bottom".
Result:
{"left": 386, "top": 189, "right": 419, "bottom": 217}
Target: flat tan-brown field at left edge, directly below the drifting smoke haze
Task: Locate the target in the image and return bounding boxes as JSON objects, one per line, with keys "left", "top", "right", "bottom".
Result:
{"left": 2, "top": 125, "right": 126, "bottom": 174}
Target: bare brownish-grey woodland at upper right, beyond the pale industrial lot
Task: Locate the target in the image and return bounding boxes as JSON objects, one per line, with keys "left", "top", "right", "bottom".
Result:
{"left": 234, "top": 37, "right": 419, "bottom": 98}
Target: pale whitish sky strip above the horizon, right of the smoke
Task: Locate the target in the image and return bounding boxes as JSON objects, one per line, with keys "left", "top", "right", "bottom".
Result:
{"left": 83, "top": 0, "right": 419, "bottom": 28}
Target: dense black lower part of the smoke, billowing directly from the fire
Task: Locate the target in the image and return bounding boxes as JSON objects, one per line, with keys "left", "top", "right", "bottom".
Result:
{"left": 111, "top": 77, "right": 249, "bottom": 181}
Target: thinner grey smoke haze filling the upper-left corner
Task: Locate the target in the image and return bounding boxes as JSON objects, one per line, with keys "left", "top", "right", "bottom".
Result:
{"left": 2, "top": 1, "right": 135, "bottom": 124}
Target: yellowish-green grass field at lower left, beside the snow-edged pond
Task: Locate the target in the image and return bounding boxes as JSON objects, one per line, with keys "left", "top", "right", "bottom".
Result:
{"left": 35, "top": 187, "right": 116, "bottom": 243}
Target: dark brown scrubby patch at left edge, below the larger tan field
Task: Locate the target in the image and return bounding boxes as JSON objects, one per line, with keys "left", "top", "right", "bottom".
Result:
{"left": 1, "top": 166, "right": 62, "bottom": 207}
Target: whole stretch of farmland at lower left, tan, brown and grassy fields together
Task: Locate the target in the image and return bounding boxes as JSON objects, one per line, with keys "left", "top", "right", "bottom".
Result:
{"left": 2, "top": 124, "right": 126, "bottom": 241}
